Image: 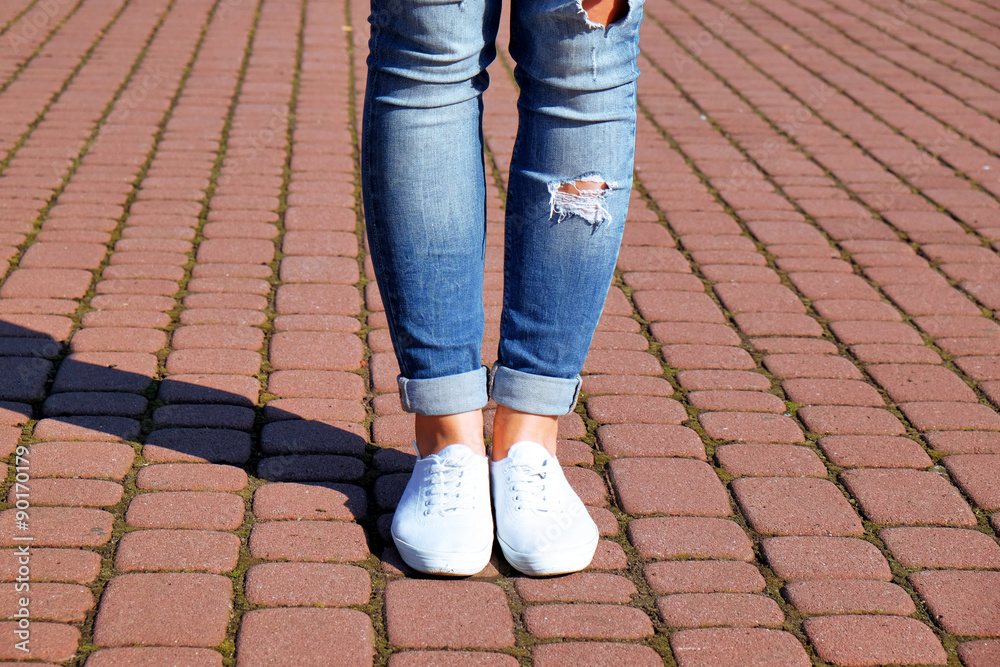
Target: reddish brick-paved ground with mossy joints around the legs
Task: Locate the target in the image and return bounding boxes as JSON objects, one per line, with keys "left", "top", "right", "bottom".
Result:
{"left": 0, "top": 0, "right": 1000, "bottom": 667}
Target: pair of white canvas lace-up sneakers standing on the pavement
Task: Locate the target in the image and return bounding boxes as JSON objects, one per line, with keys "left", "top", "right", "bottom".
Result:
{"left": 392, "top": 441, "right": 600, "bottom": 576}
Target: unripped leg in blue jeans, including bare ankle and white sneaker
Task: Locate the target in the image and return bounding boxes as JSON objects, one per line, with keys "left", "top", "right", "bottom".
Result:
{"left": 361, "top": 0, "right": 499, "bottom": 574}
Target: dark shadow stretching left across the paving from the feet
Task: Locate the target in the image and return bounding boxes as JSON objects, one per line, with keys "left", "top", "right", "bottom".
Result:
{"left": 0, "top": 315, "right": 406, "bottom": 552}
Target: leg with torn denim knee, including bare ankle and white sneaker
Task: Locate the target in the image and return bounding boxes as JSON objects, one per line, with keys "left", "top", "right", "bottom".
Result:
{"left": 490, "top": 0, "right": 642, "bottom": 575}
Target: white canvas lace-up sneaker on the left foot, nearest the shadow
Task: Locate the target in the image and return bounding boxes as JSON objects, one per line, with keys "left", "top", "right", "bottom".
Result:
{"left": 392, "top": 444, "right": 493, "bottom": 575}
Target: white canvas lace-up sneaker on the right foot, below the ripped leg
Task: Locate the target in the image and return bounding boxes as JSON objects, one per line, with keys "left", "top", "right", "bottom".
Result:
{"left": 490, "top": 441, "right": 600, "bottom": 575}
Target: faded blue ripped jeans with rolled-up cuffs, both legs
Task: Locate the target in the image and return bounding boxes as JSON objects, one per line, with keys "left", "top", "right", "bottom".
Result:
{"left": 361, "top": 0, "right": 642, "bottom": 415}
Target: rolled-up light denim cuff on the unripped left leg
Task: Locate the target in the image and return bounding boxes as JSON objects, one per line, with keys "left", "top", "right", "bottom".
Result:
{"left": 396, "top": 366, "right": 489, "bottom": 416}
